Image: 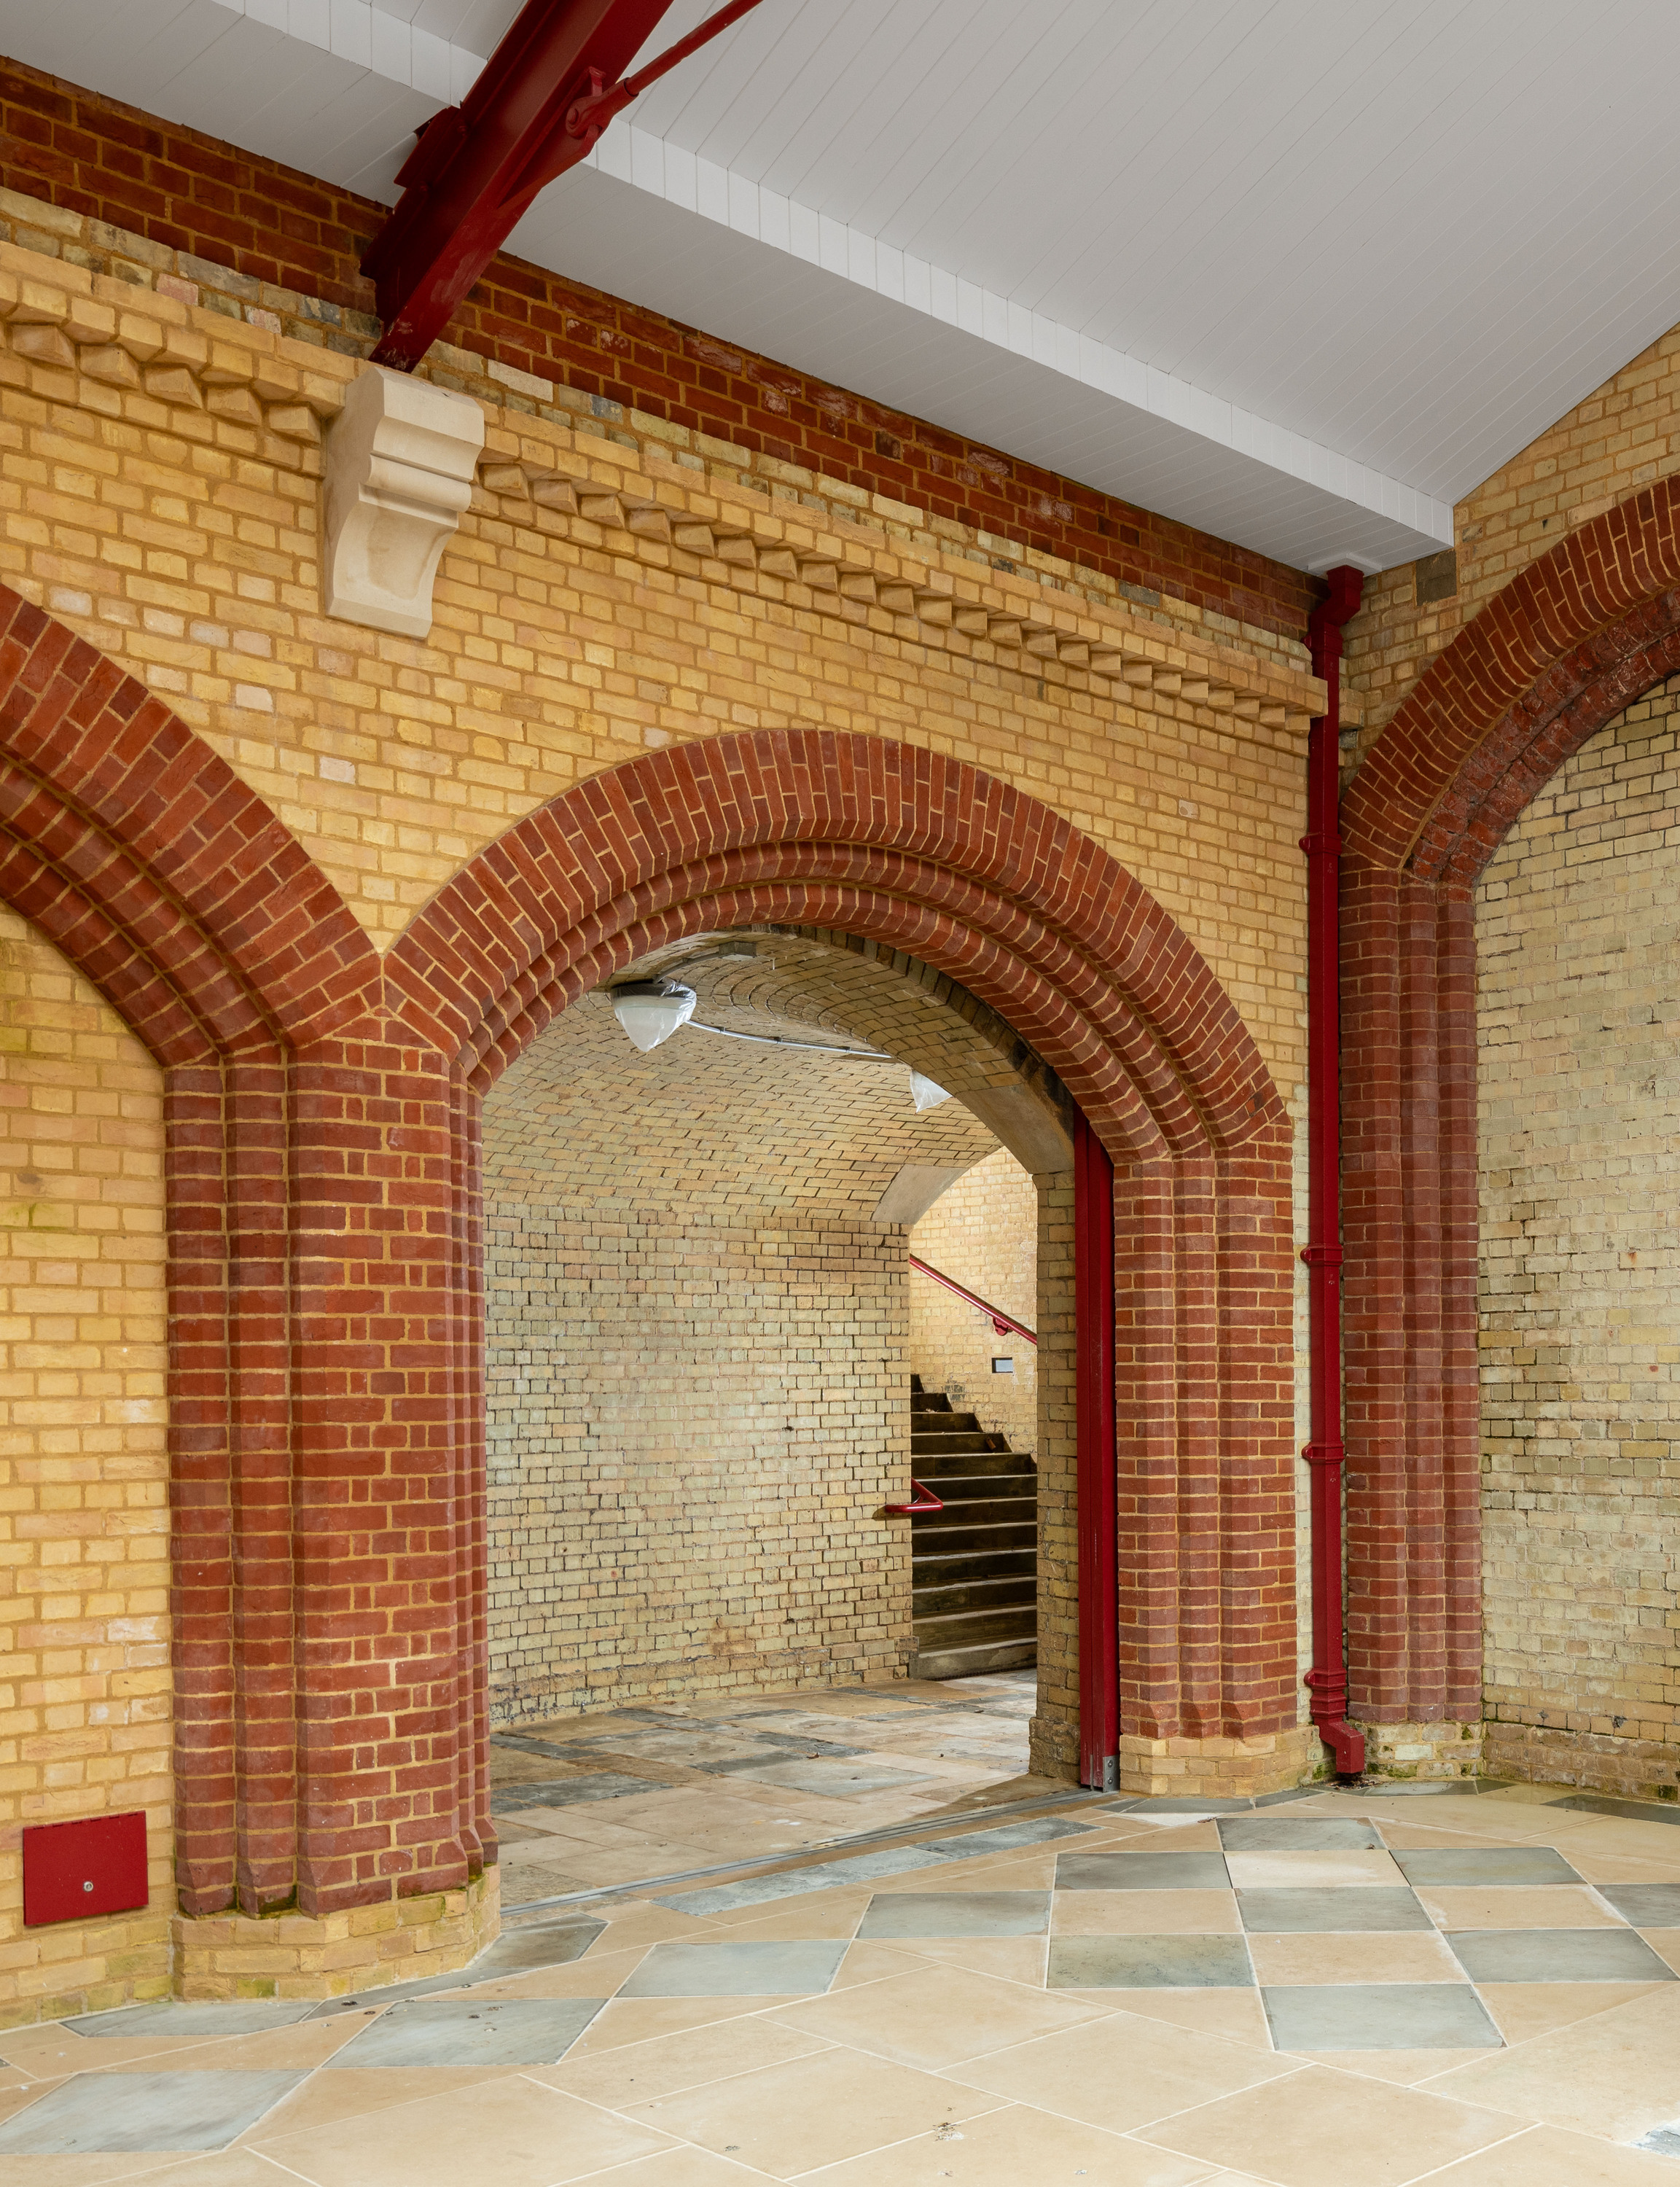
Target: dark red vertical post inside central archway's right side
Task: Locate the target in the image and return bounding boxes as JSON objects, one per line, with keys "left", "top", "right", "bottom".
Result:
{"left": 1074, "top": 1113, "right": 1120, "bottom": 1791}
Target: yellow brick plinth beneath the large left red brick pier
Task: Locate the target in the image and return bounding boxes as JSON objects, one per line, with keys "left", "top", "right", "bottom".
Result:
{"left": 173, "top": 1868, "right": 501, "bottom": 1999}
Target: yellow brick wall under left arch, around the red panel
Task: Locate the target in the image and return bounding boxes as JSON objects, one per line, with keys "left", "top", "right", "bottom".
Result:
{"left": 0, "top": 910, "right": 173, "bottom": 2025}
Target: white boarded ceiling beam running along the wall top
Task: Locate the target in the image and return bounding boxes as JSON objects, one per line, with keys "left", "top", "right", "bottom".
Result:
{"left": 509, "top": 125, "right": 1453, "bottom": 569}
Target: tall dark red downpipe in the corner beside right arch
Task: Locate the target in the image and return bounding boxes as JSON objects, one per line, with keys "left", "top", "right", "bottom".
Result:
{"left": 1302, "top": 566, "right": 1365, "bottom": 1776}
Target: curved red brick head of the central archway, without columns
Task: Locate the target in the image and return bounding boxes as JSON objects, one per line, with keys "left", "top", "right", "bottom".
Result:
{"left": 387, "top": 730, "right": 1282, "bottom": 1153}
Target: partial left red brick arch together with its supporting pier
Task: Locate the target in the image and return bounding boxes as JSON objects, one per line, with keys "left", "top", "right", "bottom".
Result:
{"left": 0, "top": 588, "right": 505, "bottom": 1914}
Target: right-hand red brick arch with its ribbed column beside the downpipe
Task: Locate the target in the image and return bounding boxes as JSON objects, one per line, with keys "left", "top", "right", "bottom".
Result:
{"left": 1341, "top": 481, "right": 1680, "bottom": 1723}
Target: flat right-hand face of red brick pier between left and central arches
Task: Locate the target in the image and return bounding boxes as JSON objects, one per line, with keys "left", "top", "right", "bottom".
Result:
{"left": 293, "top": 1019, "right": 488, "bottom": 1914}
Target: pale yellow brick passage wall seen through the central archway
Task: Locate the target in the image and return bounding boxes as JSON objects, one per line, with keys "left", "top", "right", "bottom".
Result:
{"left": 483, "top": 995, "right": 996, "bottom": 1721}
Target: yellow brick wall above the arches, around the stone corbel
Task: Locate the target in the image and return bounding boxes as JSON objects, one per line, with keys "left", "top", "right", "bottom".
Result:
{"left": 0, "top": 245, "right": 1319, "bottom": 1111}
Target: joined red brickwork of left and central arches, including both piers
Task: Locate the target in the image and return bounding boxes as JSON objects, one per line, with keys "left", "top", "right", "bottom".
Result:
{"left": 0, "top": 593, "right": 1293, "bottom": 1914}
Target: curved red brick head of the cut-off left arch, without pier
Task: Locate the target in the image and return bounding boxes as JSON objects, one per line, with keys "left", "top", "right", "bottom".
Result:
{"left": 0, "top": 584, "right": 378, "bottom": 1063}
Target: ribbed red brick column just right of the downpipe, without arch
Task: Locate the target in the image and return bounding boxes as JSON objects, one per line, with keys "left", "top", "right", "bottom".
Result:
{"left": 1343, "top": 859, "right": 1481, "bottom": 1726}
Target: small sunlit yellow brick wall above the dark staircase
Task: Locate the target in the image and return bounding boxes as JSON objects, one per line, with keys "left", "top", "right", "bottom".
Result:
{"left": 910, "top": 1146, "right": 1039, "bottom": 1450}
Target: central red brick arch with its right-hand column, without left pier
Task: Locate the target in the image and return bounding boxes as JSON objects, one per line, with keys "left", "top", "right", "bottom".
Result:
{"left": 389, "top": 730, "right": 1295, "bottom": 1739}
